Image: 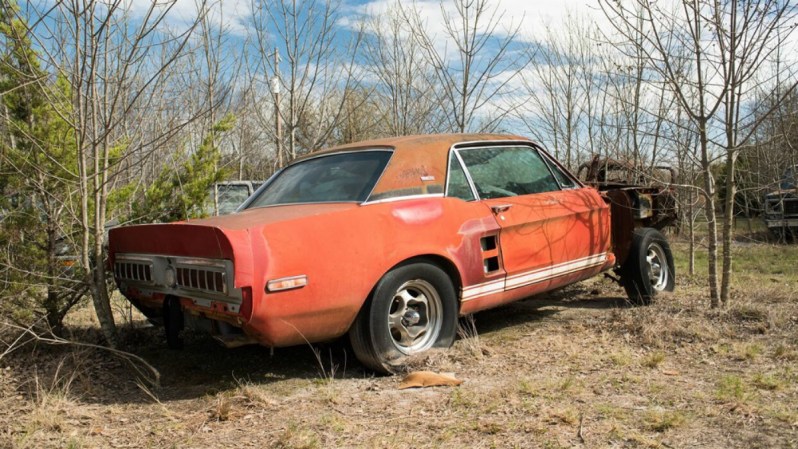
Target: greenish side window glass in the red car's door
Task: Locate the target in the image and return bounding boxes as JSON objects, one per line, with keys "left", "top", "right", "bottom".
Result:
{"left": 459, "top": 147, "right": 560, "bottom": 199}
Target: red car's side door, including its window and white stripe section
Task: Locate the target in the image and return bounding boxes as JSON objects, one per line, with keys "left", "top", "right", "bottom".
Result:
{"left": 456, "top": 145, "right": 608, "bottom": 290}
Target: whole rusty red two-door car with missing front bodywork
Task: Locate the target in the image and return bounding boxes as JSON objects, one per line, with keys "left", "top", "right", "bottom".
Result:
{"left": 109, "top": 134, "right": 675, "bottom": 372}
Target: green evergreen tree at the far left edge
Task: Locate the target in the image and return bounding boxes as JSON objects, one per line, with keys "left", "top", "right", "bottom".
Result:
{"left": 0, "top": 4, "right": 86, "bottom": 331}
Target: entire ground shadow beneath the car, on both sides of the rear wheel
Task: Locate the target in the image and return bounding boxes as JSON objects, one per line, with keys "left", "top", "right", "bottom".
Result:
{"left": 3, "top": 287, "right": 626, "bottom": 404}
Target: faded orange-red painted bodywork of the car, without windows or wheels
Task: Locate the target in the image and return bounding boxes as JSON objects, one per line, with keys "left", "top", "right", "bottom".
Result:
{"left": 109, "top": 135, "right": 615, "bottom": 346}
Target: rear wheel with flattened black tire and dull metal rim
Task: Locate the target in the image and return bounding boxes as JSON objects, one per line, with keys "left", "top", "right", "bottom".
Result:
{"left": 349, "top": 263, "right": 457, "bottom": 374}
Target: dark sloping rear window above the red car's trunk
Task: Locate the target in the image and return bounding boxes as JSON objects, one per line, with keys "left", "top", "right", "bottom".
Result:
{"left": 247, "top": 150, "right": 392, "bottom": 209}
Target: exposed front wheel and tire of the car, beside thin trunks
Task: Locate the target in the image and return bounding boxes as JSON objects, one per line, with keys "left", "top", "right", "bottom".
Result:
{"left": 620, "top": 228, "right": 676, "bottom": 305}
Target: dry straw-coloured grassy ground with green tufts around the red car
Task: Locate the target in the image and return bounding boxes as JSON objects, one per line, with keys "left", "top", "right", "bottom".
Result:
{"left": 0, "top": 236, "right": 798, "bottom": 448}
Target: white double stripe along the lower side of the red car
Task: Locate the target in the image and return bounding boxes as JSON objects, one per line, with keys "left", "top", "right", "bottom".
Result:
{"left": 461, "top": 253, "right": 607, "bottom": 301}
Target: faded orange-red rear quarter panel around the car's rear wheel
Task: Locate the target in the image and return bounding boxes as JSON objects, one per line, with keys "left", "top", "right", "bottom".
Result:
{"left": 247, "top": 198, "right": 498, "bottom": 346}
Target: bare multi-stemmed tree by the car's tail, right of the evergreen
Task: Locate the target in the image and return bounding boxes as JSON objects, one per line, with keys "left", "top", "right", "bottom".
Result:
{"left": 19, "top": 0, "right": 211, "bottom": 344}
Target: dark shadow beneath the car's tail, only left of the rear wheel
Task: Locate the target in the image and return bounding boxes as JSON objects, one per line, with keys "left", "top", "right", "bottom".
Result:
{"left": 2, "top": 322, "right": 360, "bottom": 404}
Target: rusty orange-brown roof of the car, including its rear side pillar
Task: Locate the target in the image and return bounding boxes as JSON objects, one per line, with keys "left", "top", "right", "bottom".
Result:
{"left": 291, "top": 134, "right": 532, "bottom": 201}
